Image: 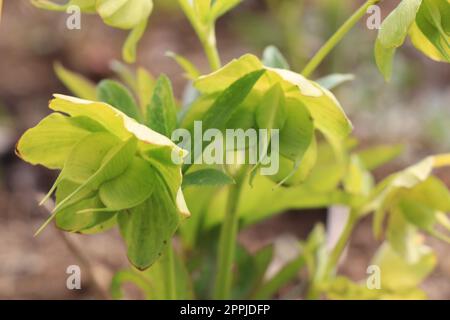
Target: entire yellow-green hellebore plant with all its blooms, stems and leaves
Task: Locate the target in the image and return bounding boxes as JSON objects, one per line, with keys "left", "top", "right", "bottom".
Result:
{"left": 17, "top": 0, "right": 450, "bottom": 299}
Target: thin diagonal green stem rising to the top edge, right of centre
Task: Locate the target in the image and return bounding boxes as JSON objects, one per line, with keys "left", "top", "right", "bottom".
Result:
{"left": 302, "top": 0, "right": 381, "bottom": 77}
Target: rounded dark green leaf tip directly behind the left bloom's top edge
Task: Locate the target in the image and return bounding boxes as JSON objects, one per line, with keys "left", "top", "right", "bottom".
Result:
{"left": 97, "top": 79, "right": 141, "bottom": 121}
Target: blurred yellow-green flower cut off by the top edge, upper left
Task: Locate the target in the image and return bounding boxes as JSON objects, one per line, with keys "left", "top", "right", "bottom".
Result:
{"left": 31, "top": 0, "right": 153, "bottom": 63}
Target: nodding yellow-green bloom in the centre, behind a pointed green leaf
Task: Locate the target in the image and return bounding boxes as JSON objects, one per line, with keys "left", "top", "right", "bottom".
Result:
{"left": 182, "top": 54, "right": 352, "bottom": 184}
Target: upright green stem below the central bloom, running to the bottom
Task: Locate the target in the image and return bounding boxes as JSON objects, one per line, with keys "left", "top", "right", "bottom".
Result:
{"left": 214, "top": 168, "right": 247, "bottom": 300}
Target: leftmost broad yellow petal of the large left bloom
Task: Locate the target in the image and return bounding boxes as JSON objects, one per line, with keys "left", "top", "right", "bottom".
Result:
{"left": 16, "top": 113, "right": 100, "bottom": 169}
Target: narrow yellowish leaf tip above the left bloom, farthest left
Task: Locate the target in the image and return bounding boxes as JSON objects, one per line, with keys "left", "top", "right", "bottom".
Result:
{"left": 53, "top": 62, "right": 96, "bottom": 100}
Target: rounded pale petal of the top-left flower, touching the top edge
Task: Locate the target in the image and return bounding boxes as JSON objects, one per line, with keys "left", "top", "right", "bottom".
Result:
{"left": 96, "top": 0, "right": 153, "bottom": 29}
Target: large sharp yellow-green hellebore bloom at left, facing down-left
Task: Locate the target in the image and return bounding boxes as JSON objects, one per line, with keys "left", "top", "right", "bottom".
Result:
{"left": 16, "top": 95, "right": 189, "bottom": 269}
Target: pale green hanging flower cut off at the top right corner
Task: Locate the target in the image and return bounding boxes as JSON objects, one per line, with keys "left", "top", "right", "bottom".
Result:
{"left": 375, "top": 0, "right": 450, "bottom": 80}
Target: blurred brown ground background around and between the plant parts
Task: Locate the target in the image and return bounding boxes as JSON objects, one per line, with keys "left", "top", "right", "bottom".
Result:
{"left": 0, "top": 0, "right": 450, "bottom": 299}
